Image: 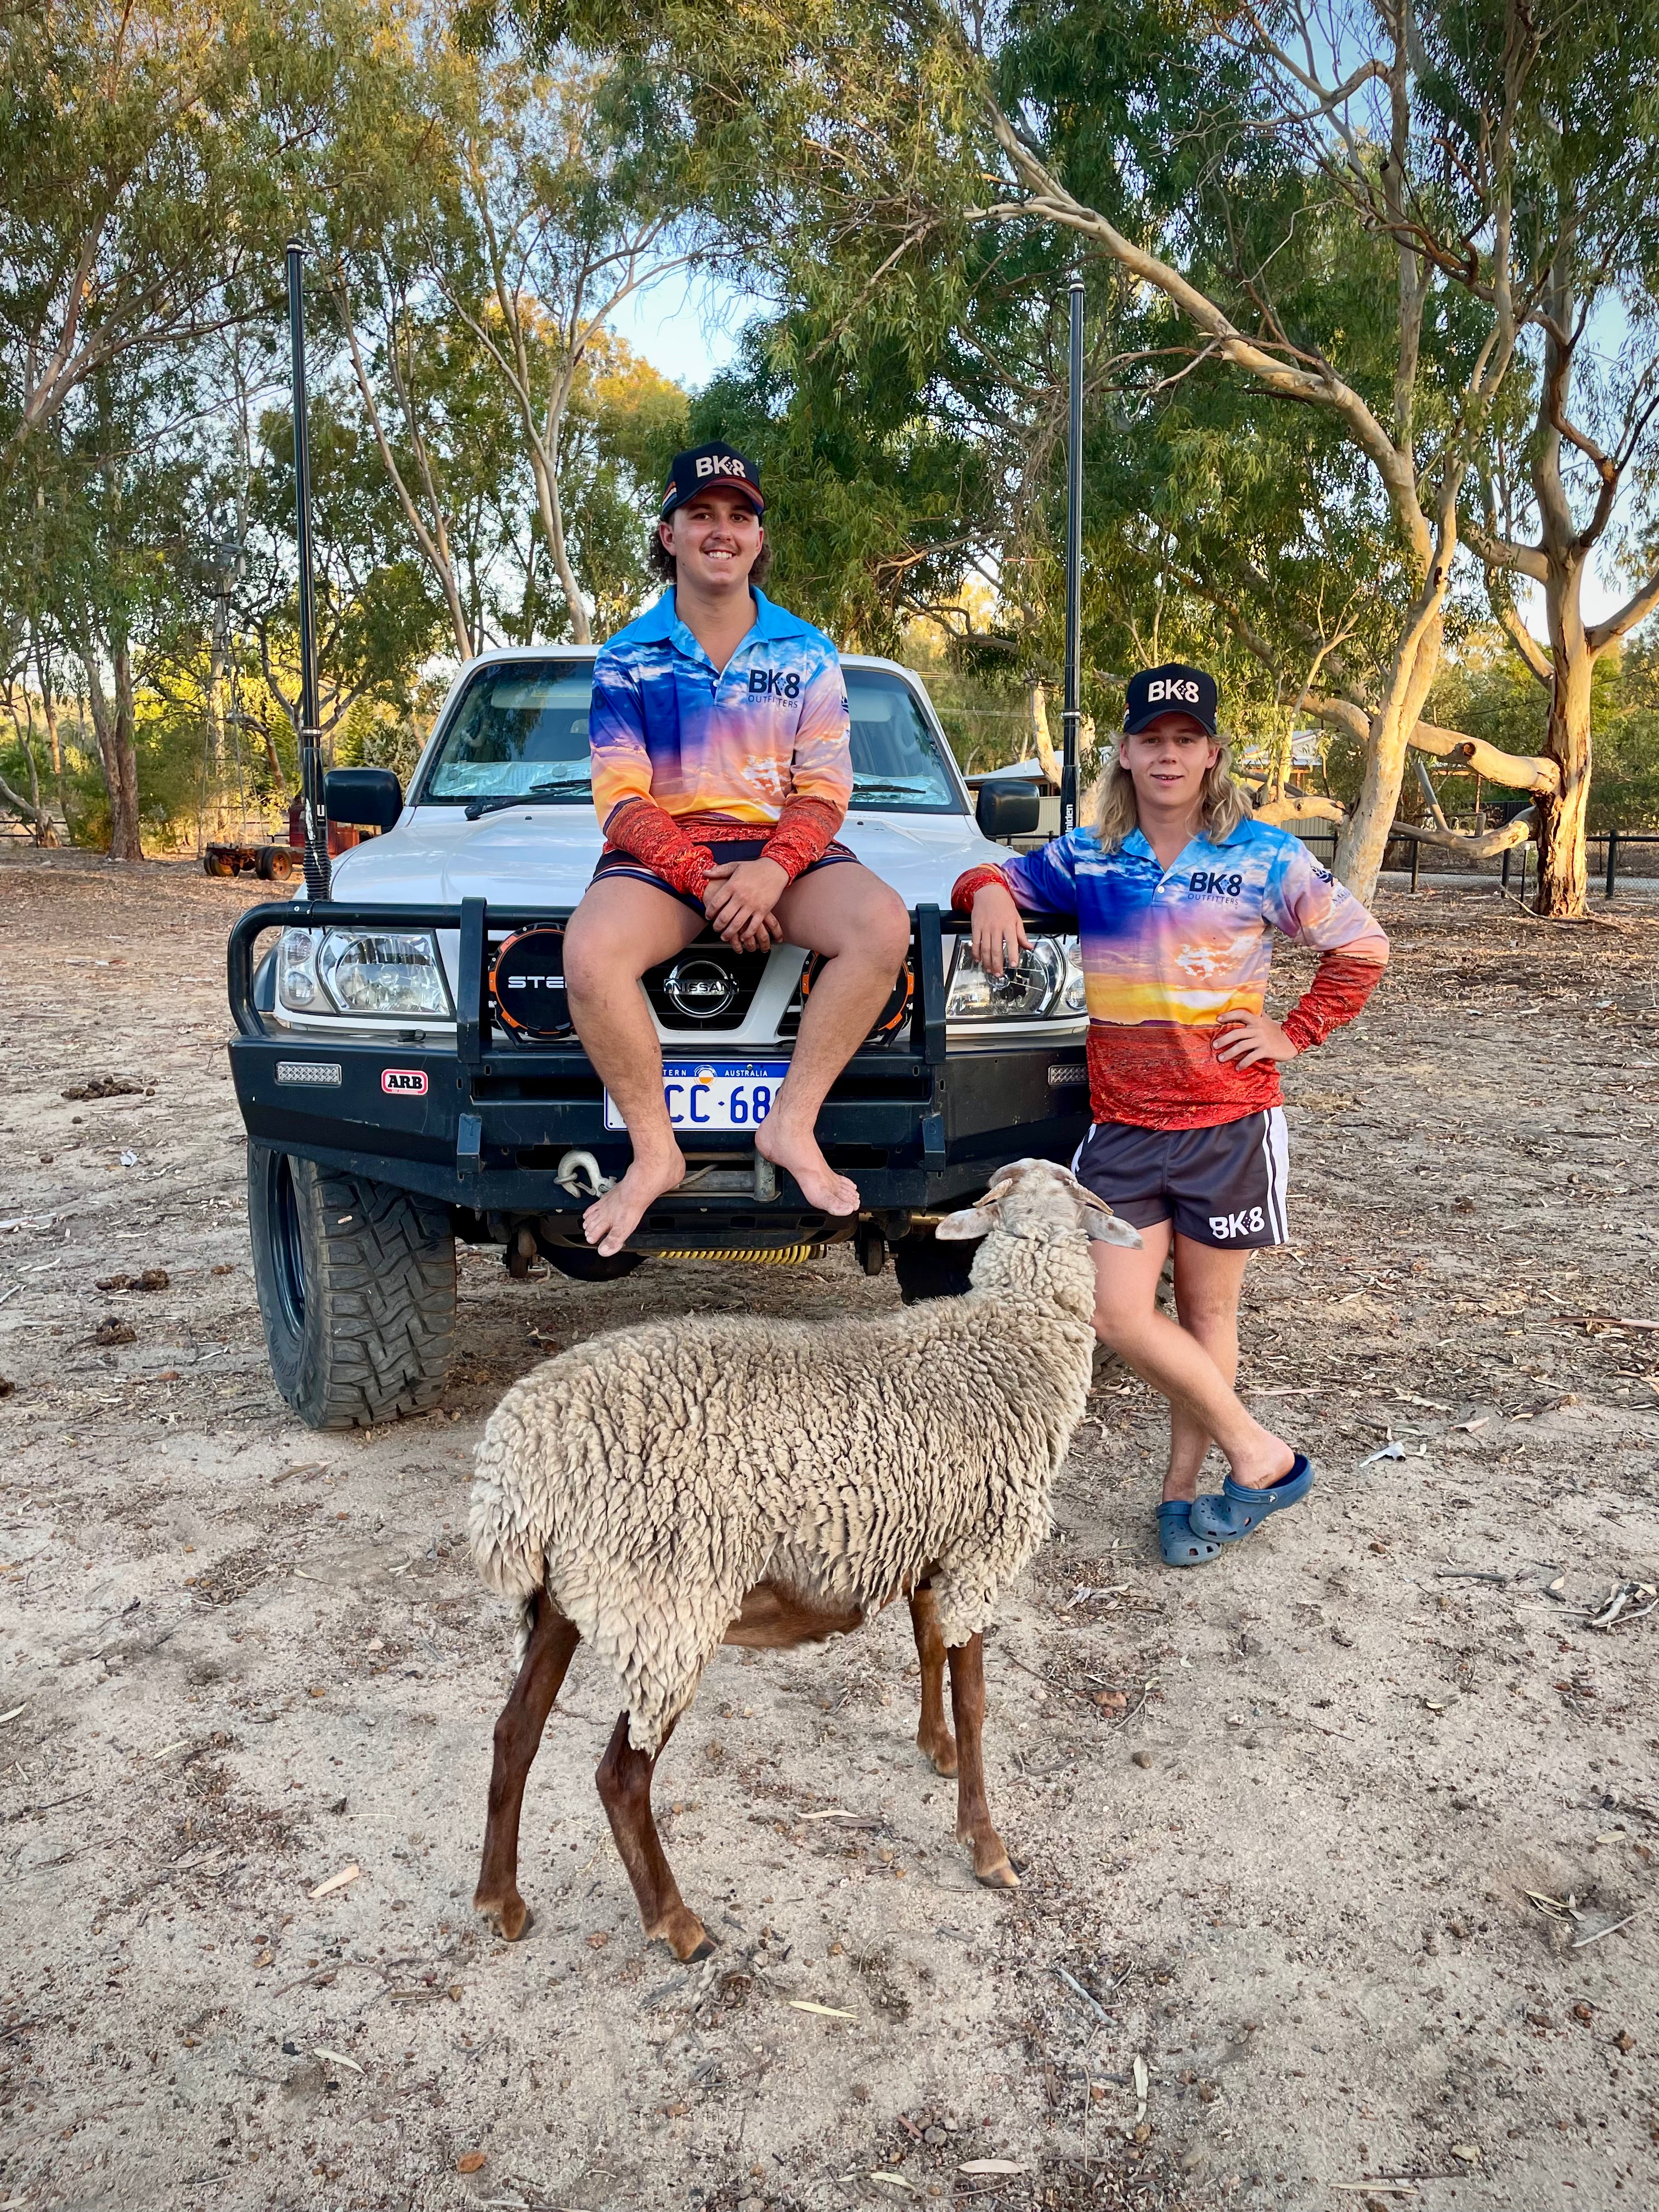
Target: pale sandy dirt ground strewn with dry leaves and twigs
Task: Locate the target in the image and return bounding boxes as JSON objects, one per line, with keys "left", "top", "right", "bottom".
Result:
{"left": 0, "top": 849, "right": 1659, "bottom": 2212}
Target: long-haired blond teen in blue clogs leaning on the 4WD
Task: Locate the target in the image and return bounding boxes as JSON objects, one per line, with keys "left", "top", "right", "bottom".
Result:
{"left": 953, "top": 664, "right": 1389, "bottom": 1566}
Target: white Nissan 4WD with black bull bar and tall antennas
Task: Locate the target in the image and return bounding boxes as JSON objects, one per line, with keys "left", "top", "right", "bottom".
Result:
{"left": 228, "top": 646, "right": 1088, "bottom": 1429}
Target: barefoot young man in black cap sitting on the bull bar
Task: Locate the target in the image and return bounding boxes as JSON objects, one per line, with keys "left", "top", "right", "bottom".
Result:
{"left": 564, "top": 444, "right": 909, "bottom": 1256}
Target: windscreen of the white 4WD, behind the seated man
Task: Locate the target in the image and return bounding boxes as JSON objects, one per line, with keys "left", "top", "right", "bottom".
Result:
{"left": 420, "top": 662, "right": 962, "bottom": 814}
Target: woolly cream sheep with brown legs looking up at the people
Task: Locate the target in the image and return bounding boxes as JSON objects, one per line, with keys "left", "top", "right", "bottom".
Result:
{"left": 469, "top": 1159, "right": 1139, "bottom": 1960}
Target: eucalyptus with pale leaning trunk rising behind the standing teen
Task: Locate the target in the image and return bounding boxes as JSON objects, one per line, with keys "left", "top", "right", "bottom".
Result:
{"left": 560, "top": 0, "right": 1645, "bottom": 889}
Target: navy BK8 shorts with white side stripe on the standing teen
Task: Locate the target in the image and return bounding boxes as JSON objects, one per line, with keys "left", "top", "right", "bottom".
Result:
{"left": 1070, "top": 1106, "right": 1290, "bottom": 1252}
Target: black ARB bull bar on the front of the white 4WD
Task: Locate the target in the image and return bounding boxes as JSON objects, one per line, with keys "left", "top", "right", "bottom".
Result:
{"left": 225, "top": 898, "right": 1088, "bottom": 1243}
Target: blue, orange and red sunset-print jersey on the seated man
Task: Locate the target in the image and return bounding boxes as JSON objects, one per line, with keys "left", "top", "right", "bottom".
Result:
{"left": 589, "top": 586, "right": 851, "bottom": 896}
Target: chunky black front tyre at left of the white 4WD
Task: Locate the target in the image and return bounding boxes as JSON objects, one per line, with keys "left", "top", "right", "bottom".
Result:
{"left": 248, "top": 1144, "right": 456, "bottom": 1429}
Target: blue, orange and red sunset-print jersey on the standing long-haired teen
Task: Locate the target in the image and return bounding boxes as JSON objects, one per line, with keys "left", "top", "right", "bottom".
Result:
{"left": 953, "top": 821, "right": 1389, "bottom": 1128}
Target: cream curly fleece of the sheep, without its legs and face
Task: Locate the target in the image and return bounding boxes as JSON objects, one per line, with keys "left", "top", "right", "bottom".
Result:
{"left": 469, "top": 1237, "right": 1093, "bottom": 1752}
